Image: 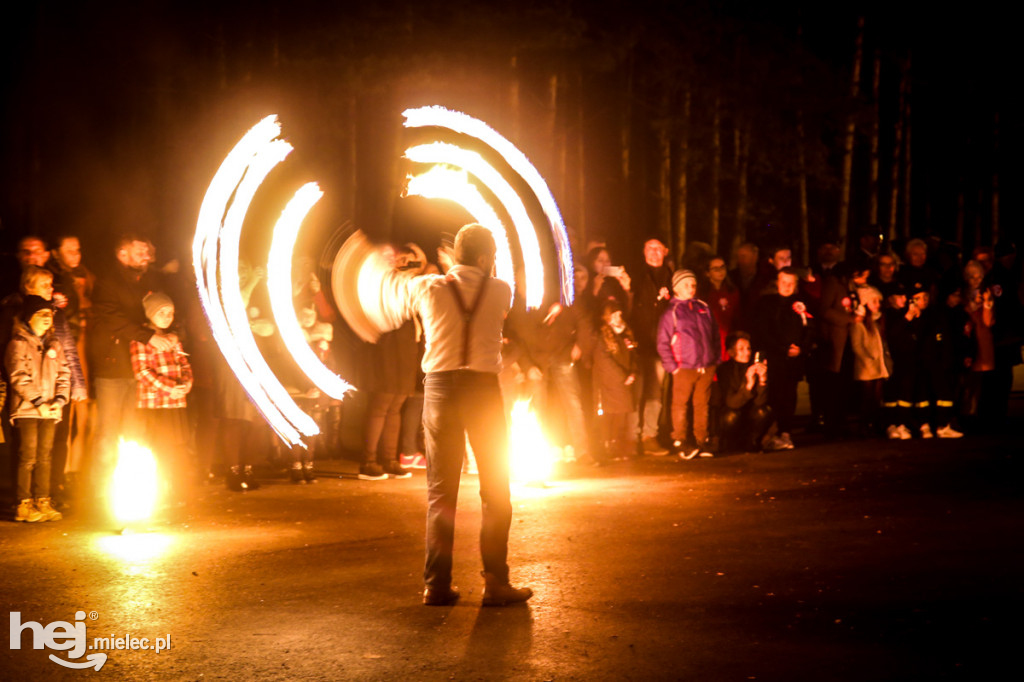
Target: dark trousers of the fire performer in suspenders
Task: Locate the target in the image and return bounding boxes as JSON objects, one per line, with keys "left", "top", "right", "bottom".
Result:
{"left": 423, "top": 370, "right": 512, "bottom": 588}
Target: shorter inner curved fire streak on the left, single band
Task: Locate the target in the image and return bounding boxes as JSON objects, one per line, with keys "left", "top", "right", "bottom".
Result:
{"left": 266, "top": 182, "right": 352, "bottom": 399}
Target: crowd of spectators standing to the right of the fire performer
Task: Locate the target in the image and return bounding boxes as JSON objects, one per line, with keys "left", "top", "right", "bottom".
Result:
{"left": 505, "top": 230, "right": 1024, "bottom": 465}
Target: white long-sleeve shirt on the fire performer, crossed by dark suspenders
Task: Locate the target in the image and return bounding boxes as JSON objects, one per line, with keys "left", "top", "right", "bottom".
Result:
{"left": 377, "top": 265, "right": 512, "bottom": 374}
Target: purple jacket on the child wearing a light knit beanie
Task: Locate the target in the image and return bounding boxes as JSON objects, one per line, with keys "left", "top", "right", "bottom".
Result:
{"left": 657, "top": 297, "right": 721, "bottom": 373}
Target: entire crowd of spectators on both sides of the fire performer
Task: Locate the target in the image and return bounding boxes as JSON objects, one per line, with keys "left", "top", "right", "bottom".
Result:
{"left": 0, "top": 225, "right": 1024, "bottom": 521}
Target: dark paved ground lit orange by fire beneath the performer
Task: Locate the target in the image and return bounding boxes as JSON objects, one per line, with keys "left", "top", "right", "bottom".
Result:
{"left": 0, "top": 404, "right": 1024, "bottom": 680}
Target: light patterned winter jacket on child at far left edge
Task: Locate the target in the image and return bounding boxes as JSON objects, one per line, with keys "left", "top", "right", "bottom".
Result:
{"left": 4, "top": 319, "right": 71, "bottom": 422}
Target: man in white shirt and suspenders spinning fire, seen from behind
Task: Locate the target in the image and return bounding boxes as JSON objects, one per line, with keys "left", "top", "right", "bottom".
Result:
{"left": 336, "top": 224, "right": 534, "bottom": 606}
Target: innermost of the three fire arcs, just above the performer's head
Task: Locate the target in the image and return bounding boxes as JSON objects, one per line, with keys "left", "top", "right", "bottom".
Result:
{"left": 406, "top": 166, "right": 515, "bottom": 283}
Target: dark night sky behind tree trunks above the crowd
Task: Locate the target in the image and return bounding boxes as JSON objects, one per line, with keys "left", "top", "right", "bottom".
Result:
{"left": 0, "top": 0, "right": 1021, "bottom": 270}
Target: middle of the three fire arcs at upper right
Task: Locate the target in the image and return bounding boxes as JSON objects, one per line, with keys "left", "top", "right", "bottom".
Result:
{"left": 406, "top": 142, "right": 544, "bottom": 308}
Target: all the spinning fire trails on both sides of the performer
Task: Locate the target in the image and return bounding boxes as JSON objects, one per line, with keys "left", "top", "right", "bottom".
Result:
{"left": 193, "top": 106, "right": 573, "bottom": 446}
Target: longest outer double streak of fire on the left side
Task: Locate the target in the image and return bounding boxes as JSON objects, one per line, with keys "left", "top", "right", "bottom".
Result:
{"left": 193, "top": 116, "right": 319, "bottom": 444}
